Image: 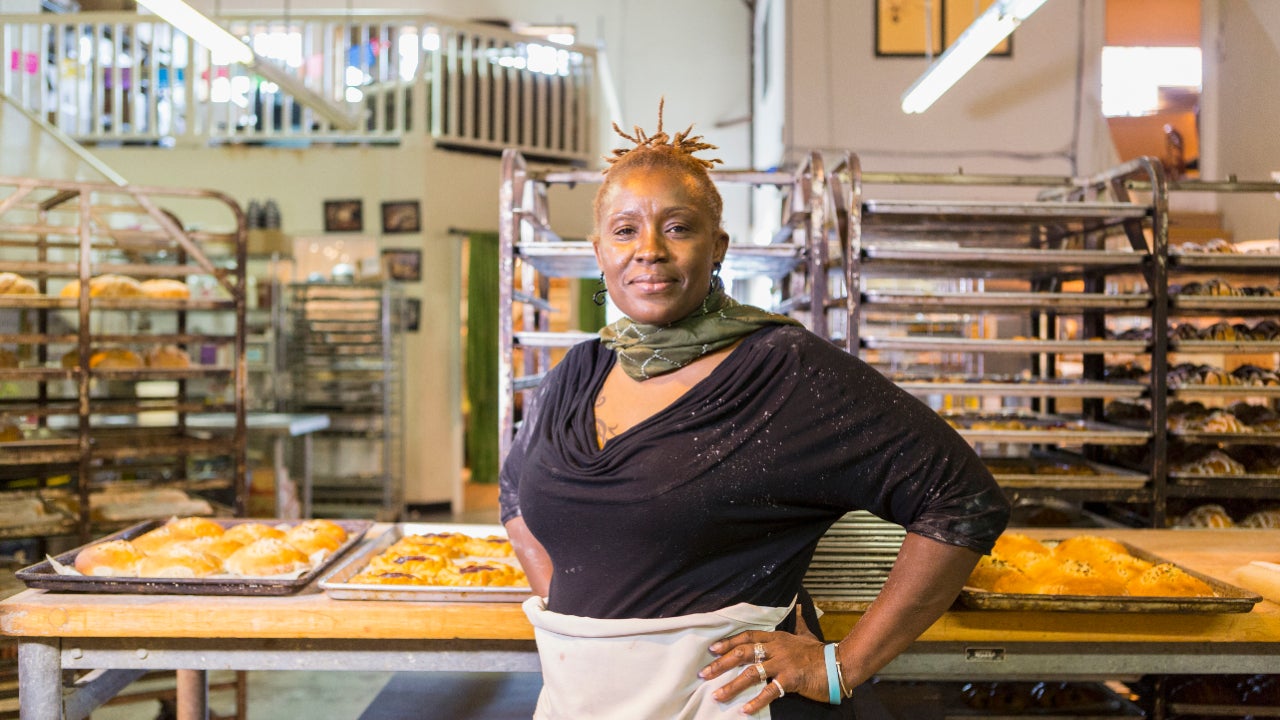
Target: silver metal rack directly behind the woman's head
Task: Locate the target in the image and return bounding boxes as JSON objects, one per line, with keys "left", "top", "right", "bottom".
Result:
{"left": 498, "top": 150, "right": 852, "bottom": 457}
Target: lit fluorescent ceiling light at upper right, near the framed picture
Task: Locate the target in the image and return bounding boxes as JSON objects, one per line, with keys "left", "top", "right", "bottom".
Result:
{"left": 901, "top": 0, "right": 1046, "bottom": 113}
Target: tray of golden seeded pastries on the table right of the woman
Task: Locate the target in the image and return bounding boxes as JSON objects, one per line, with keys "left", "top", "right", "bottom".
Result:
{"left": 960, "top": 532, "right": 1262, "bottom": 612}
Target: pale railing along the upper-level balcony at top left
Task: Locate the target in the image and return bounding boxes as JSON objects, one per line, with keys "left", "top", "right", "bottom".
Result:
{"left": 0, "top": 12, "right": 596, "bottom": 161}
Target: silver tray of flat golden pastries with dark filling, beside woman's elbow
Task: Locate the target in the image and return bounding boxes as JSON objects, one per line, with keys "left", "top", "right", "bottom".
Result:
{"left": 320, "top": 523, "right": 532, "bottom": 602}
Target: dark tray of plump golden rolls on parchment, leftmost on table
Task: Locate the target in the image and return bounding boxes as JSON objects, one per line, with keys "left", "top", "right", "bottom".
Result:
{"left": 15, "top": 516, "right": 372, "bottom": 596}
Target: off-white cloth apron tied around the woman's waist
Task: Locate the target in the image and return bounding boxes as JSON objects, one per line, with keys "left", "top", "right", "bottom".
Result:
{"left": 524, "top": 596, "right": 794, "bottom": 720}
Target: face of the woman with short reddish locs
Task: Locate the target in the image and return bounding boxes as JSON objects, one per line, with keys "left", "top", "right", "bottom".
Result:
{"left": 594, "top": 168, "right": 728, "bottom": 325}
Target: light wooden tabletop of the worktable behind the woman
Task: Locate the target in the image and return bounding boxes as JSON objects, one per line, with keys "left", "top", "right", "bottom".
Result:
{"left": 0, "top": 529, "right": 1280, "bottom": 643}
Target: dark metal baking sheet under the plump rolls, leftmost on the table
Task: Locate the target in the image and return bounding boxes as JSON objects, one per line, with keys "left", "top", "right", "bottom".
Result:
{"left": 15, "top": 518, "right": 372, "bottom": 596}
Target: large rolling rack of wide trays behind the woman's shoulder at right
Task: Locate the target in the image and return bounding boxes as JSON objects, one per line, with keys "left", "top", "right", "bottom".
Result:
{"left": 837, "top": 158, "right": 1167, "bottom": 527}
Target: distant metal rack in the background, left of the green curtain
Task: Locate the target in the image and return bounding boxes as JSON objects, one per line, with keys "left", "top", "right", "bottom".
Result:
{"left": 285, "top": 283, "right": 404, "bottom": 521}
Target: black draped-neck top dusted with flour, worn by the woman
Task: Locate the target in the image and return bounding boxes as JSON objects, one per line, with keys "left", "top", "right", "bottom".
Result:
{"left": 500, "top": 327, "right": 1009, "bottom": 618}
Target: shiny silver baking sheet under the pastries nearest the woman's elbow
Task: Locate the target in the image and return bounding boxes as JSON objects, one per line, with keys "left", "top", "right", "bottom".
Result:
{"left": 320, "top": 523, "right": 534, "bottom": 602}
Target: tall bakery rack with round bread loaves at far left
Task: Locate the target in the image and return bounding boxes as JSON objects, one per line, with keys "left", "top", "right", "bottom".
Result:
{"left": 0, "top": 177, "right": 247, "bottom": 539}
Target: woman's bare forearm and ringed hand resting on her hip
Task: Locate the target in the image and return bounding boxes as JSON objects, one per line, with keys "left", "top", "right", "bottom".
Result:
{"left": 700, "top": 533, "right": 980, "bottom": 714}
